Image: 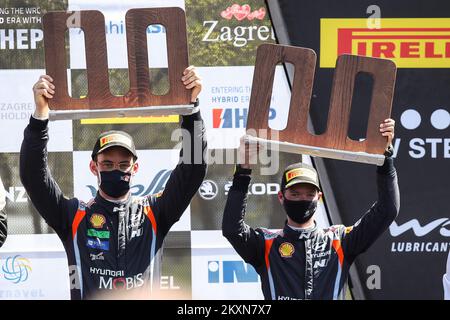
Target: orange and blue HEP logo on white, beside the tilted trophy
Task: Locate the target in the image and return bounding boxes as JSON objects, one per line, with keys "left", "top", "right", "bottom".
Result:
{"left": 212, "top": 108, "right": 277, "bottom": 129}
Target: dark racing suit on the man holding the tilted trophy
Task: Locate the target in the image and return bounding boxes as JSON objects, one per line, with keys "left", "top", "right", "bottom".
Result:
{"left": 222, "top": 158, "right": 400, "bottom": 300}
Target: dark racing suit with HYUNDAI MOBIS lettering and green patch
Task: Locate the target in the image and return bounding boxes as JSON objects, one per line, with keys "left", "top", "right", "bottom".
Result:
{"left": 20, "top": 112, "right": 207, "bottom": 299}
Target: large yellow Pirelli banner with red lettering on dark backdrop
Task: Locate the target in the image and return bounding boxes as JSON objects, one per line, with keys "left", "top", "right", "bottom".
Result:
{"left": 320, "top": 18, "right": 450, "bottom": 68}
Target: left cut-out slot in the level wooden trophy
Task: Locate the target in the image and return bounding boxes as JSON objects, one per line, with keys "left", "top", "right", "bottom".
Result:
{"left": 65, "top": 27, "right": 89, "bottom": 99}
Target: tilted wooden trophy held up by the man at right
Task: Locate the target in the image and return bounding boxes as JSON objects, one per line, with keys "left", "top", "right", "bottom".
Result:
{"left": 247, "top": 44, "right": 396, "bottom": 165}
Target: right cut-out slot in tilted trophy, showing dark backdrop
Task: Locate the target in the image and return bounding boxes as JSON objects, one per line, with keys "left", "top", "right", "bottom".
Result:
{"left": 348, "top": 72, "right": 374, "bottom": 141}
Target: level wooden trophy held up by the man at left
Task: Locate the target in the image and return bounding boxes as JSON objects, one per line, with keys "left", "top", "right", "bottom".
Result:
{"left": 43, "top": 8, "right": 194, "bottom": 120}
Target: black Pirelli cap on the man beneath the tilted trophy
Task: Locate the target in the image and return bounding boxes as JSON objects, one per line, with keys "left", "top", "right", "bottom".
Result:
{"left": 281, "top": 162, "right": 320, "bottom": 191}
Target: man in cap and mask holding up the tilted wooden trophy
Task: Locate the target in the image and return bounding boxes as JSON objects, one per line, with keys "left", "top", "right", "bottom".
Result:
{"left": 222, "top": 119, "right": 400, "bottom": 300}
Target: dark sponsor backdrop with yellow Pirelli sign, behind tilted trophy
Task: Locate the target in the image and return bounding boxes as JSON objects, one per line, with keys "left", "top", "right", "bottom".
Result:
{"left": 279, "top": 0, "right": 450, "bottom": 299}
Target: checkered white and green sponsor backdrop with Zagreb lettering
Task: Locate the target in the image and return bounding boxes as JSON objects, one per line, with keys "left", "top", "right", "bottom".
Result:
{"left": 0, "top": 0, "right": 328, "bottom": 299}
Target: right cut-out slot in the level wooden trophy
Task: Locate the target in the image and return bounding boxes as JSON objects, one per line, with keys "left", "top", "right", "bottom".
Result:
{"left": 147, "top": 24, "right": 169, "bottom": 96}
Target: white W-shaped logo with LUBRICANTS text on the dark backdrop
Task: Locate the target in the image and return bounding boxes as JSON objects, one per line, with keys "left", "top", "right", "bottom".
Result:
{"left": 389, "top": 218, "right": 450, "bottom": 253}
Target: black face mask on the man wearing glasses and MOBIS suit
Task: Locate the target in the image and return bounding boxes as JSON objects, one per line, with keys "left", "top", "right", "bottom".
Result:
{"left": 100, "top": 170, "right": 131, "bottom": 198}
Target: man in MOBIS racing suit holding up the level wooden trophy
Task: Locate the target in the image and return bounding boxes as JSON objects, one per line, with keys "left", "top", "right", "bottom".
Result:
{"left": 20, "top": 67, "right": 206, "bottom": 299}
